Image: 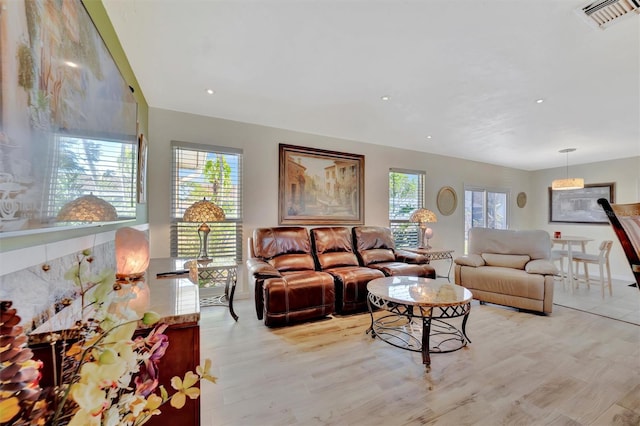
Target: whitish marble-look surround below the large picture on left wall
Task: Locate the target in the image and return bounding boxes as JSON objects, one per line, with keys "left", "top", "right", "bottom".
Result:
{"left": 0, "top": 230, "right": 139, "bottom": 333}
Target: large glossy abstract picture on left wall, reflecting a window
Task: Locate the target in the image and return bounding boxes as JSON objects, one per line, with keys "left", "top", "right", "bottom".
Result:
{"left": 0, "top": 0, "right": 138, "bottom": 236}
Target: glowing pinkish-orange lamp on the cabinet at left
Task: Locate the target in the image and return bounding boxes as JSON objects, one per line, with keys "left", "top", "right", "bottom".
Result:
{"left": 116, "top": 228, "right": 149, "bottom": 279}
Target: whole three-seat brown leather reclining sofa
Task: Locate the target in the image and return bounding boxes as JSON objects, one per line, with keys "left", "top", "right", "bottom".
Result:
{"left": 246, "top": 227, "right": 435, "bottom": 326}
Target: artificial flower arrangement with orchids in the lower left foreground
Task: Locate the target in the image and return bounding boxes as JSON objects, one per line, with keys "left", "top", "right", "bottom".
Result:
{"left": 0, "top": 250, "right": 216, "bottom": 426}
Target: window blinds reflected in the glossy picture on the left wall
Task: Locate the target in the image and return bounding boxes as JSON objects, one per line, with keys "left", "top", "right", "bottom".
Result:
{"left": 47, "top": 134, "right": 138, "bottom": 219}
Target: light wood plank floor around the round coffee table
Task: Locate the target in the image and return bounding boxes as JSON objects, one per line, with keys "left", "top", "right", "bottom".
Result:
{"left": 201, "top": 298, "right": 640, "bottom": 426}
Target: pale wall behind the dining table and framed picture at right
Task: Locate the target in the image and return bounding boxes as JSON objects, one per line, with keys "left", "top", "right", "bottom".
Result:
{"left": 529, "top": 157, "right": 640, "bottom": 283}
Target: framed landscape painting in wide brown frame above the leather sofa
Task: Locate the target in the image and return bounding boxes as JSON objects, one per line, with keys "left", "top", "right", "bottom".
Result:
{"left": 278, "top": 144, "right": 364, "bottom": 225}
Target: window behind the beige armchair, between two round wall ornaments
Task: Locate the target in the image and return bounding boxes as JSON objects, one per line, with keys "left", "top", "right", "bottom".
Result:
{"left": 464, "top": 187, "right": 509, "bottom": 253}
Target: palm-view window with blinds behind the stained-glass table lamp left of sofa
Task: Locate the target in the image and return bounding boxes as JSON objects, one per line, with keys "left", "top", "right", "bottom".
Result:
{"left": 171, "top": 142, "right": 242, "bottom": 262}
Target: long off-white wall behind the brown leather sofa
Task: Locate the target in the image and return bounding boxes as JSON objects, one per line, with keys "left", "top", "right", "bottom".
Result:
{"left": 148, "top": 108, "right": 532, "bottom": 293}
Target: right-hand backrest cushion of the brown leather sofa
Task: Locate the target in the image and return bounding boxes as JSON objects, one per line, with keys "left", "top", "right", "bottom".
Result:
{"left": 352, "top": 226, "right": 396, "bottom": 266}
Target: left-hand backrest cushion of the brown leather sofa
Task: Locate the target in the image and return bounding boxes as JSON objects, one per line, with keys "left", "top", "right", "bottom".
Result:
{"left": 253, "top": 226, "right": 315, "bottom": 272}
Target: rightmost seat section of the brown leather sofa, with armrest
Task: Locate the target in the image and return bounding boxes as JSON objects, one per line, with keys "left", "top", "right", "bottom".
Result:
{"left": 352, "top": 226, "right": 436, "bottom": 278}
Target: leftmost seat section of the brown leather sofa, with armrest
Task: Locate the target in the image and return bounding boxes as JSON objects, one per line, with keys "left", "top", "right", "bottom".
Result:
{"left": 246, "top": 227, "right": 335, "bottom": 326}
